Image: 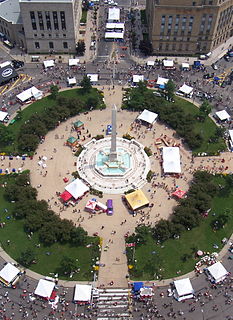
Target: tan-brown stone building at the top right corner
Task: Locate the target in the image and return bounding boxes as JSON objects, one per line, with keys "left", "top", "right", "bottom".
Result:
{"left": 146, "top": 0, "right": 233, "bottom": 56}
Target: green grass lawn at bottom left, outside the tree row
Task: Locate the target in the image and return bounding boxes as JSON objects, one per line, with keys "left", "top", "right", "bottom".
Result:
{"left": 0, "top": 176, "right": 97, "bottom": 280}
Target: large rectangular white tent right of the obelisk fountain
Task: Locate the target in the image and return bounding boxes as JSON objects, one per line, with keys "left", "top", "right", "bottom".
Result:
{"left": 163, "top": 147, "right": 181, "bottom": 173}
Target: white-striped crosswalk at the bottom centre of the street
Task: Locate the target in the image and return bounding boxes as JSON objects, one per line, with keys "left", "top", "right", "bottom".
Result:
{"left": 93, "top": 288, "right": 131, "bottom": 320}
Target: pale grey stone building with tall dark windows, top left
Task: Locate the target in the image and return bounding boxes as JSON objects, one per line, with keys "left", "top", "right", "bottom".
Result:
{"left": 19, "top": 0, "right": 82, "bottom": 54}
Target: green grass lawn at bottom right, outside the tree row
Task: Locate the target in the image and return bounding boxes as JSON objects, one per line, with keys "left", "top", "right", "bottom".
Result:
{"left": 128, "top": 175, "right": 233, "bottom": 280}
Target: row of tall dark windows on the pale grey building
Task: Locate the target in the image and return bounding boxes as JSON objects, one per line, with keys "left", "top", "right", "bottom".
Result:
{"left": 30, "top": 11, "right": 66, "bottom": 30}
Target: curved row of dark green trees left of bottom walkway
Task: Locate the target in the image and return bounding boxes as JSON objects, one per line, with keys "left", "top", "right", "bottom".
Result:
{"left": 5, "top": 172, "right": 87, "bottom": 246}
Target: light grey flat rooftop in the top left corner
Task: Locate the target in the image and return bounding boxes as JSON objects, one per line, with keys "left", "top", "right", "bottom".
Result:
{"left": 0, "top": 0, "right": 23, "bottom": 24}
